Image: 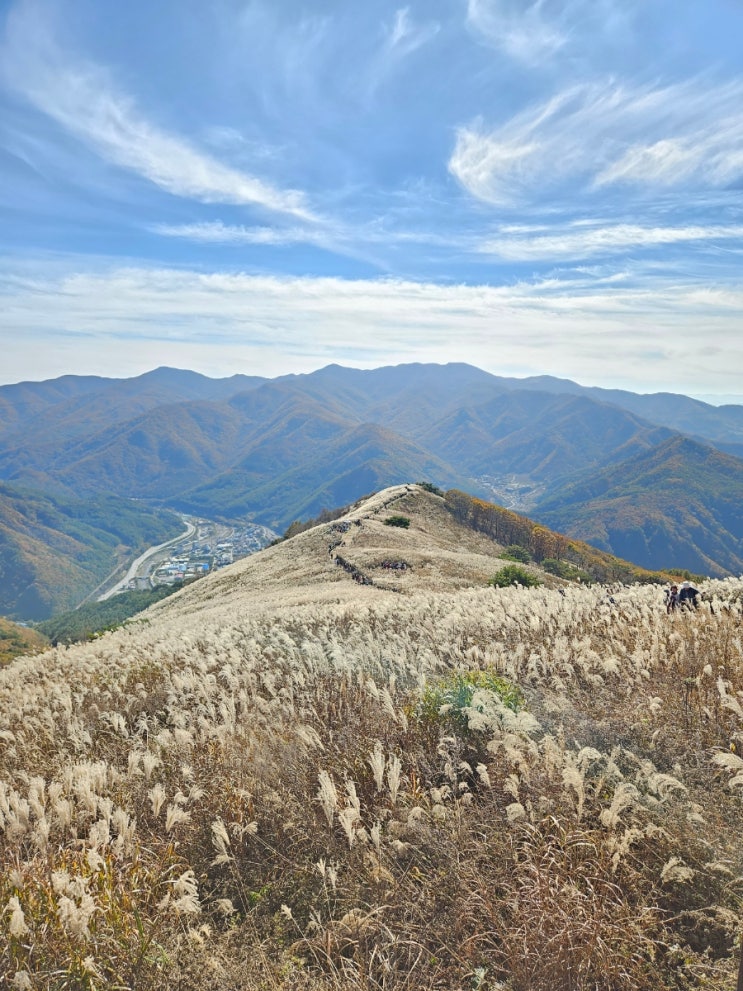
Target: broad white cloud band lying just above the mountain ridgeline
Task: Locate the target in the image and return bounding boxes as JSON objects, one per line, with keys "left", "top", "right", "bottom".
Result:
{"left": 0, "top": 269, "right": 743, "bottom": 393}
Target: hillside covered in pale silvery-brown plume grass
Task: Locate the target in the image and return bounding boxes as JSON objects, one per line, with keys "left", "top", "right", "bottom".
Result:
{"left": 0, "top": 486, "right": 743, "bottom": 991}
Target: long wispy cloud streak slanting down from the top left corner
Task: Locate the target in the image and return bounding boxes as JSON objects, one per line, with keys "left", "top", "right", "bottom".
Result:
{"left": 0, "top": 2, "right": 312, "bottom": 219}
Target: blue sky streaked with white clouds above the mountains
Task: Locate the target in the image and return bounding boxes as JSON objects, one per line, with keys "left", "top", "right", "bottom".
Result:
{"left": 0, "top": 0, "right": 743, "bottom": 402}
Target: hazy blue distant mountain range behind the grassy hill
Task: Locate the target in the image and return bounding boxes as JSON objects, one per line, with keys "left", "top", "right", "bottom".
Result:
{"left": 0, "top": 364, "right": 743, "bottom": 612}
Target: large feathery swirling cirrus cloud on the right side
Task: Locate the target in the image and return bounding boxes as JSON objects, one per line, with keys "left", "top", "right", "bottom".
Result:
{"left": 449, "top": 79, "right": 743, "bottom": 206}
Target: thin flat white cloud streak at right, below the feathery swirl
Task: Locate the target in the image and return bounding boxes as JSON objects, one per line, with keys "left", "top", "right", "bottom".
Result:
{"left": 479, "top": 222, "right": 743, "bottom": 261}
